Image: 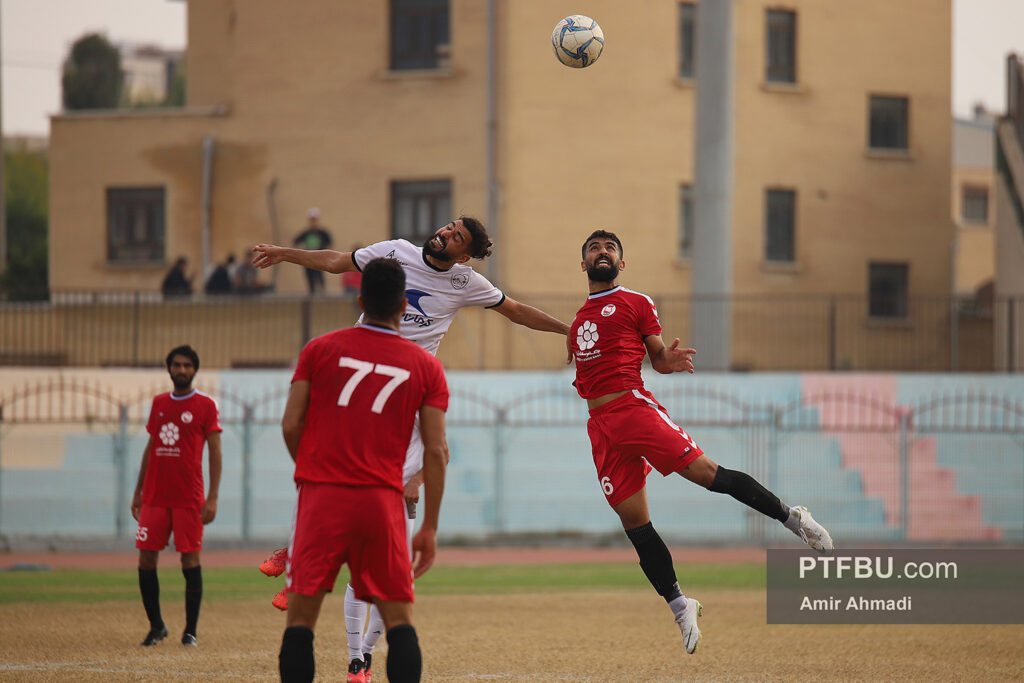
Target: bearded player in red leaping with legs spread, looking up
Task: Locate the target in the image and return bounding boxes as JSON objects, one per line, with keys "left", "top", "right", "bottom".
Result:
{"left": 567, "top": 230, "right": 833, "bottom": 654}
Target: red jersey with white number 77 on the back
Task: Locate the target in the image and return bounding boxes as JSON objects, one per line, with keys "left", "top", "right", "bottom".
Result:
{"left": 292, "top": 325, "right": 449, "bottom": 492}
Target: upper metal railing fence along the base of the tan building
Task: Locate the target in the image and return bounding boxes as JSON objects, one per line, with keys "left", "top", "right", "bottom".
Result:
{"left": 0, "top": 292, "right": 1024, "bottom": 372}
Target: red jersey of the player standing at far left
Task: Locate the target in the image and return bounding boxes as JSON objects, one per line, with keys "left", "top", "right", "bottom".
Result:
{"left": 142, "top": 390, "right": 222, "bottom": 508}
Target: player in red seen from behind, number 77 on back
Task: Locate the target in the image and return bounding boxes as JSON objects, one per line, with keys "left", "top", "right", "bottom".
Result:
{"left": 279, "top": 258, "right": 449, "bottom": 683}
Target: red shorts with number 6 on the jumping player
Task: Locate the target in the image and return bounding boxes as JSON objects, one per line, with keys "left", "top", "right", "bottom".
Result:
{"left": 587, "top": 389, "right": 703, "bottom": 507}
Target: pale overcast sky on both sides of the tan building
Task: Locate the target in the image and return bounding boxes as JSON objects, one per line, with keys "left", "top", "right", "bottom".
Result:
{"left": 0, "top": 0, "right": 1024, "bottom": 135}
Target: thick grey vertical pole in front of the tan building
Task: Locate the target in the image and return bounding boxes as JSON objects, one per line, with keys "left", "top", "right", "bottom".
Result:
{"left": 690, "top": 0, "right": 735, "bottom": 371}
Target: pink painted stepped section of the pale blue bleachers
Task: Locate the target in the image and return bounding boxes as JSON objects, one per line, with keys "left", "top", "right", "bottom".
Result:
{"left": 802, "top": 374, "right": 1001, "bottom": 541}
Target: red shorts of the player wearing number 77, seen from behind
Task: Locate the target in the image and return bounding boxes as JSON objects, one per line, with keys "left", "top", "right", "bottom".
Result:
{"left": 287, "top": 483, "right": 413, "bottom": 602}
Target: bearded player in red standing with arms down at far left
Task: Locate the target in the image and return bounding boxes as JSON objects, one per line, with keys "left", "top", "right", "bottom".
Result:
{"left": 131, "top": 346, "right": 221, "bottom": 647}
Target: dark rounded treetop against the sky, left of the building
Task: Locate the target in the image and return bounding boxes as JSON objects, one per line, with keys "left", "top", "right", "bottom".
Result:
{"left": 60, "top": 33, "right": 124, "bottom": 111}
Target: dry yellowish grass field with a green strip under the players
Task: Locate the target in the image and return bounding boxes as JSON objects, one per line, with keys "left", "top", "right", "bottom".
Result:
{"left": 0, "top": 563, "right": 1024, "bottom": 681}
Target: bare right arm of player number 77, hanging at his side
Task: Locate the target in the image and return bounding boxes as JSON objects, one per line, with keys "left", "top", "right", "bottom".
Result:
{"left": 413, "top": 405, "right": 447, "bottom": 579}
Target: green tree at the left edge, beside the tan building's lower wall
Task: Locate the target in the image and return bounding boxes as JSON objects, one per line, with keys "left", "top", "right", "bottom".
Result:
{"left": 0, "top": 150, "right": 49, "bottom": 300}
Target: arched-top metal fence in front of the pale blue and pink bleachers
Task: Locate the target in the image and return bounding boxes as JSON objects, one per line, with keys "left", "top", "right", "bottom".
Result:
{"left": 0, "top": 374, "right": 1024, "bottom": 547}
